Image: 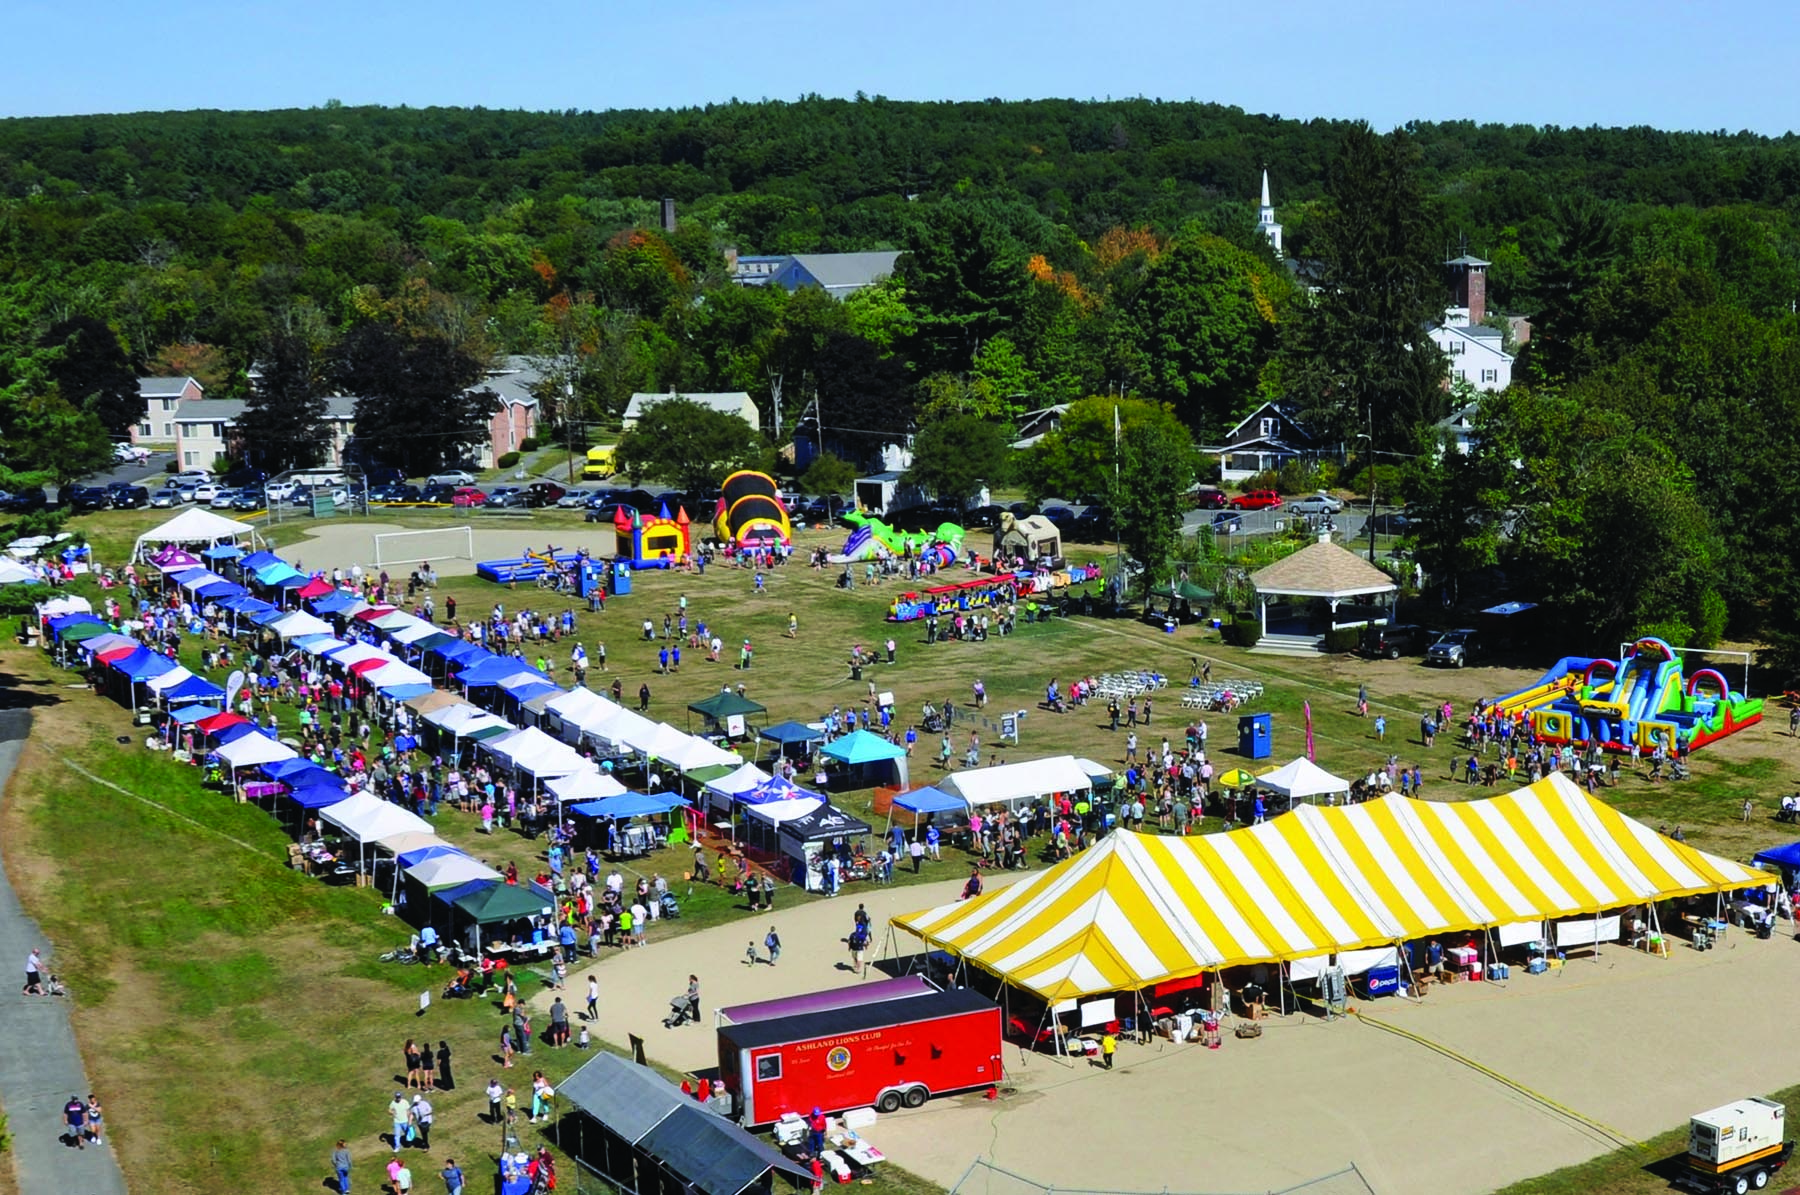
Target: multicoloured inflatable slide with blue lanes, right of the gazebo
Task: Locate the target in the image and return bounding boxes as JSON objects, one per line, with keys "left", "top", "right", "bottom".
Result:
{"left": 1494, "top": 639, "right": 1762, "bottom": 750}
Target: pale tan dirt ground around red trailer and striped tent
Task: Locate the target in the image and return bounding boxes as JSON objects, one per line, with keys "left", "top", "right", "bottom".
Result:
{"left": 540, "top": 880, "right": 1800, "bottom": 1193}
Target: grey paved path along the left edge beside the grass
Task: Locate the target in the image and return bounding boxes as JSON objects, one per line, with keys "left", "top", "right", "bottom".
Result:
{"left": 0, "top": 709, "right": 126, "bottom": 1195}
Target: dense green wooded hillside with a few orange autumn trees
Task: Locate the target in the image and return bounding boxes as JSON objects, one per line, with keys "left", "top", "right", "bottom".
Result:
{"left": 0, "top": 97, "right": 1800, "bottom": 651}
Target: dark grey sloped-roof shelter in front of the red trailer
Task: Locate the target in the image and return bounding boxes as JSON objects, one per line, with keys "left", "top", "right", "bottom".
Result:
{"left": 556, "top": 1055, "right": 812, "bottom": 1195}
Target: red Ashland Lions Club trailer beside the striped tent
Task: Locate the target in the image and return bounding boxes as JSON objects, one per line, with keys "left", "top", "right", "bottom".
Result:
{"left": 718, "top": 988, "right": 1001, "bottom": 1125}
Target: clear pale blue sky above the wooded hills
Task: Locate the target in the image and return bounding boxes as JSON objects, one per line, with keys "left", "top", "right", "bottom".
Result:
{"left": 14, "top": 0, "right": 1800, "bottom": 133}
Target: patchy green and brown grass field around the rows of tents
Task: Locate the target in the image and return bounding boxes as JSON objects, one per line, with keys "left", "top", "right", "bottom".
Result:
{"left": 0, "top": 511, "right": 1796, "bottom": 1193}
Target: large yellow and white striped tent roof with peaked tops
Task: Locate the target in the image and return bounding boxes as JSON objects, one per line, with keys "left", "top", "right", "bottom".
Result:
{"left": 893, "top": 774, "right": 1775, "bottom": 1001}
